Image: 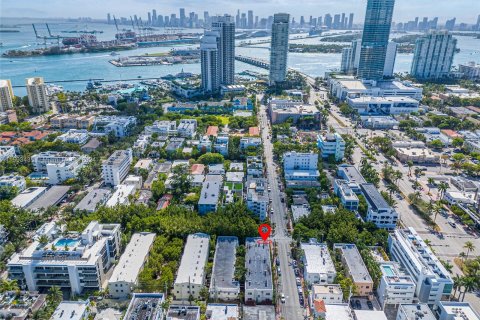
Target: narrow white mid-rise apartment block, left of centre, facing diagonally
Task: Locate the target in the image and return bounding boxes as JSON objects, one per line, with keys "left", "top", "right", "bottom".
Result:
{"left": 102, "top": 149, "right": 133, "bottom": 186}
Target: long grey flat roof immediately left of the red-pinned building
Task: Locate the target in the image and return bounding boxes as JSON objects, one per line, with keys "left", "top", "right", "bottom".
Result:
{"left": 210, "top": 237, "right": 240, "bottom": 291}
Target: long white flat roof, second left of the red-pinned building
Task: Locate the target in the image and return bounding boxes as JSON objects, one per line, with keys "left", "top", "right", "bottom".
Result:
{"left": 175, "top": 233, "right": 210, "bottom": 285}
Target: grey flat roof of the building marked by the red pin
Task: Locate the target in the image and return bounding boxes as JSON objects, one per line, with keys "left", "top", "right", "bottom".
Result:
{"left": 245, "top": 238, "right": 273, "bottom": 290}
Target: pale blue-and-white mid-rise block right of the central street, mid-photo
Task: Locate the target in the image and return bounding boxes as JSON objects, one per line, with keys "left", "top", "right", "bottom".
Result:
{"left": 283, "top": 151, "right": 320, "bottom": 181}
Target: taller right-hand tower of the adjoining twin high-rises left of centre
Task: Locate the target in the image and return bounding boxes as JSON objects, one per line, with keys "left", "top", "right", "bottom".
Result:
{"left": 212, "top": 15, "right": 235, "bottom": 85}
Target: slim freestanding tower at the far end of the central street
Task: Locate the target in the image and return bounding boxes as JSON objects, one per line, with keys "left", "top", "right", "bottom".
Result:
{"left": 269, "top": 13, "right": 290, "bottom": 85}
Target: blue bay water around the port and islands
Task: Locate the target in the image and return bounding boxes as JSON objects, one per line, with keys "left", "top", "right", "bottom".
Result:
{"left": 0, "top": 19, "right": 480, "bottom": 95}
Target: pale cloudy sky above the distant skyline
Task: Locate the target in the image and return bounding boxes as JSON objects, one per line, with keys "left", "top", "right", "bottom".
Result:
{"left": 0, "top": 0, "right": 480, "bottom": 23}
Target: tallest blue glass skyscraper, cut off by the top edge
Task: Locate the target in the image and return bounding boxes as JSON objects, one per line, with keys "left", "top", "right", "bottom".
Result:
{"left": 357, "top": 0, "right": 395, "bottom": 80}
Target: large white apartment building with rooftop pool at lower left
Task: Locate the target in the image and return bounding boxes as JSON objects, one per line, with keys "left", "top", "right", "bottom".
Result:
{"left": 7, "top": 221, "right": 120, "bottom": 294}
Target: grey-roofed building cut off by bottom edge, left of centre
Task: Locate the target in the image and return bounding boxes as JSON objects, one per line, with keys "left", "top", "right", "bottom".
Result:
{"left": 123, "top": 293, "right": 166, "bottom": 320}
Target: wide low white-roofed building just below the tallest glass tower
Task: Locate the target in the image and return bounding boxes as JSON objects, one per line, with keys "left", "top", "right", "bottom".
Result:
{"left": 347, "top": 96, "right": 420, "bottom": 116}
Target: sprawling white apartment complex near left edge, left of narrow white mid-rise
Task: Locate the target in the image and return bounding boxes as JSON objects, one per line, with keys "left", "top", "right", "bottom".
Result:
{"left": 32, "top": 151, "right": 91, "bottom": 184}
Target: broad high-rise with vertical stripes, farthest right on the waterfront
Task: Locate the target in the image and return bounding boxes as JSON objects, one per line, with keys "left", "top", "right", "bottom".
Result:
{"left": 410, "top": 30, "right": 457, "bottom": 79}
